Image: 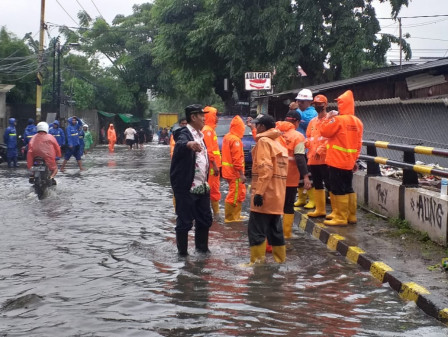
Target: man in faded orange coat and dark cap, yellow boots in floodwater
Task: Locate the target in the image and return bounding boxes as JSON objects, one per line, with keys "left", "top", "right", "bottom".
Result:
{"left": 248, "top": 115, "right": 288, "bottom": 264}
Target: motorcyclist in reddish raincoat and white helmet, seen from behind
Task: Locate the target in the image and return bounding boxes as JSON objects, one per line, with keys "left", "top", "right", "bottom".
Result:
{"left": 26, "top": 122, "right": 61, "bottom": 184}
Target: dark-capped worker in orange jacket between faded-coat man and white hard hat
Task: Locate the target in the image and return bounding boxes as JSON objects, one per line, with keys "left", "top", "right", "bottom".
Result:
{"left": 276, "top": 110, "right": 311, "bottom": 239}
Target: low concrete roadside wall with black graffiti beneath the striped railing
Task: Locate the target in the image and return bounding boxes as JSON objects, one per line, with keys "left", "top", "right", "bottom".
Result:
{"left": 353, "top": 172, "right": 448, "bottom": 246}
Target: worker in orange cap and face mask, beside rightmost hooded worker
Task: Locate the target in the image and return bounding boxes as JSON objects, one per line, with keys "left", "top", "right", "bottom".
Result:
{"left": 305, "top": 95, "right": 332, "bottom": 218}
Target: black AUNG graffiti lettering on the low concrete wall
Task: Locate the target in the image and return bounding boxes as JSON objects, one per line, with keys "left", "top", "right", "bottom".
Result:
{"left": 411, "top": 195, "right": 445, "bottom": 229}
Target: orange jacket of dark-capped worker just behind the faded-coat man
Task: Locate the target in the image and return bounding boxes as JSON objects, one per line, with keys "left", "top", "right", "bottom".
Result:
{"left": 275, "top": 121, "right": 305, "bottom": 187}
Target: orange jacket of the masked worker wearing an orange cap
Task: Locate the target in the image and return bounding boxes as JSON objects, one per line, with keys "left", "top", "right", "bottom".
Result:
{"left": 305, "top": 117, "right": 327, "bottom": 165}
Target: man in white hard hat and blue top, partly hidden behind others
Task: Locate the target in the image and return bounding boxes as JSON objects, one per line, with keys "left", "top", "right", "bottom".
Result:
{"left": 289, "top": 89, "right": 317, "bottom": 208}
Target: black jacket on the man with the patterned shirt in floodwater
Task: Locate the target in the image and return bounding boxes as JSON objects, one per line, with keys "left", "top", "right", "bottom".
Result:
{"left": 170, "top": 126, "right": 208, "bottom": 193}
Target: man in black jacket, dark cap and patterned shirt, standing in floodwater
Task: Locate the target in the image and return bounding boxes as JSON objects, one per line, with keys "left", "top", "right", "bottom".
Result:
{"left": 170, "top": 104, "right": 213, "bottom": 256}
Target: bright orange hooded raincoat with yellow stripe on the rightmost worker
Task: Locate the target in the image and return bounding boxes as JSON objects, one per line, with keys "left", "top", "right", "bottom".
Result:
{"left": 320, "top": 90, "right": 363, "bottom": 170}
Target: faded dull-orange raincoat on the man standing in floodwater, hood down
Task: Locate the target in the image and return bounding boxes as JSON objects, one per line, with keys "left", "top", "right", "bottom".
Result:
{"left": 250, "top": 127, "right": 288, "bottom": 214}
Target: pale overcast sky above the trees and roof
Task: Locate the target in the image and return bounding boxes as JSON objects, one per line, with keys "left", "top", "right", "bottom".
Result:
{"left": 0, "top": 0, "right": 448, "bottom": 60}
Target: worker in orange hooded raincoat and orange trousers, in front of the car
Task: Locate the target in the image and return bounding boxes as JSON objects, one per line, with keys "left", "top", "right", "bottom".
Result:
{"left": 222, "top": 116, "right": 246, "bottom": 222}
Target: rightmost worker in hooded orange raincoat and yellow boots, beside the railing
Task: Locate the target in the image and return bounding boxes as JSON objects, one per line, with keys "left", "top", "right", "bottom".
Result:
{"left": 320, "top": 90, "right": 363, "bottom": 226}
